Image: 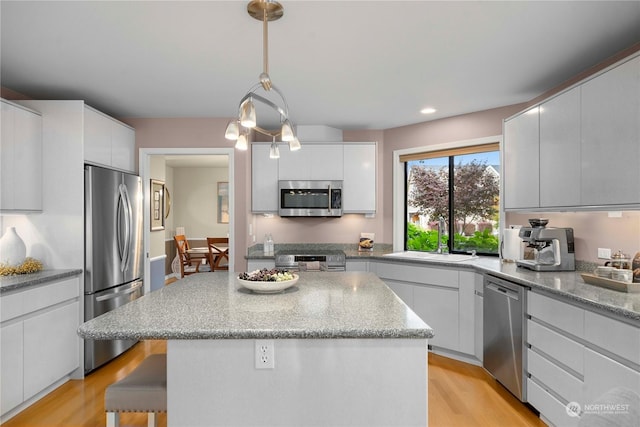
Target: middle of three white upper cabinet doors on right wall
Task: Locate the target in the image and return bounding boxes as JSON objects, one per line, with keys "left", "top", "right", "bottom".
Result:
{"left": 540, "top": 87, "right": 581, "bottom": 207}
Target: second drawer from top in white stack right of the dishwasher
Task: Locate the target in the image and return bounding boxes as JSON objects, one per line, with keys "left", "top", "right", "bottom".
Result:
{"left": 527, "top": 320, "right": 584, "bottom": 375}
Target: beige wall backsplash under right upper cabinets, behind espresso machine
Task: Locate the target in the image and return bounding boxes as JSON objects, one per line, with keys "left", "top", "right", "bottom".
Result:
{"left": 504, "top": 211, "right": 640, "bottom": 264}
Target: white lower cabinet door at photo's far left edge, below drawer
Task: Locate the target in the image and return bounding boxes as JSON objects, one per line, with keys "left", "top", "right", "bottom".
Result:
{"left": 0, "top": 322, "right": 23, "bottom": 414}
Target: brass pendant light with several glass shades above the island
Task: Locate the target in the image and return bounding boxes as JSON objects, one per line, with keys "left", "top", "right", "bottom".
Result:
{"left": 224, "top": 0, "right": 300, "bottom": 159}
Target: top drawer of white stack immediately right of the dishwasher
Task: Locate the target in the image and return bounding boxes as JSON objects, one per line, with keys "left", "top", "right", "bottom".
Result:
{"left": 527, "top": 292, "right": 584, "bottom": 338}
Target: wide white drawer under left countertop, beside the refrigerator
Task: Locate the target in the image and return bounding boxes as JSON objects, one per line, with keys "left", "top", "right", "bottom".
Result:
{"left": 0, "top": 277, "right": 80, "bottom": 322}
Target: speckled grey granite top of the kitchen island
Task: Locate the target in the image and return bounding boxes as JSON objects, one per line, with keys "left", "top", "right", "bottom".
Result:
{"left": 78, "top": 272, "right": 434, "bottom": 339}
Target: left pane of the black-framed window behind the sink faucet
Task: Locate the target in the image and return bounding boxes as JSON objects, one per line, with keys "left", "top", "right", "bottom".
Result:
{"left": 406, "top": 157, "right": 449, "bottom": 251}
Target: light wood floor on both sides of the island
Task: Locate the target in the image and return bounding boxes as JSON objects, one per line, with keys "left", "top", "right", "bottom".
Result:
{"left": 2, "top": 341, "right": 545, "bottom": 427}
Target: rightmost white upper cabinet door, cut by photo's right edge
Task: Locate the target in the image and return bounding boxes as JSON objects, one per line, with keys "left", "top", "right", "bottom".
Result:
{"left": 581, "top": 57, "right": 640, "bottom": 206}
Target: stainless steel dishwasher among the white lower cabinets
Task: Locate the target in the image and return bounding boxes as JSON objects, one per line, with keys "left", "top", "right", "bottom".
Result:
{"left": 483, "top": 275, "right": 527, "bottom": 402}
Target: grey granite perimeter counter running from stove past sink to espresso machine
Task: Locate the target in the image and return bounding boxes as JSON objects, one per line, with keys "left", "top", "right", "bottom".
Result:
{"left": 247, "top": 244, "right": 640, "bottom": 322}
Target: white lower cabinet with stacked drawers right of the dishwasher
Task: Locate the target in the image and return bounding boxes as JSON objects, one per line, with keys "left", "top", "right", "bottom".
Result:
{"left": 527, "top": 291, "right": 640, "bottom": 426}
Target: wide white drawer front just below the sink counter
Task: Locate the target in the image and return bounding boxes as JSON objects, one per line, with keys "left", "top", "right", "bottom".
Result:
{"left": 376, "top": 263, "right": 458, "bottom": 289}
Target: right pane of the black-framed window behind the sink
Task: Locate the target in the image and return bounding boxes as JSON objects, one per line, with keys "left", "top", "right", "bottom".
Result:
{"left": 452, "top": 151, "right": 500, "bottom": 254}
